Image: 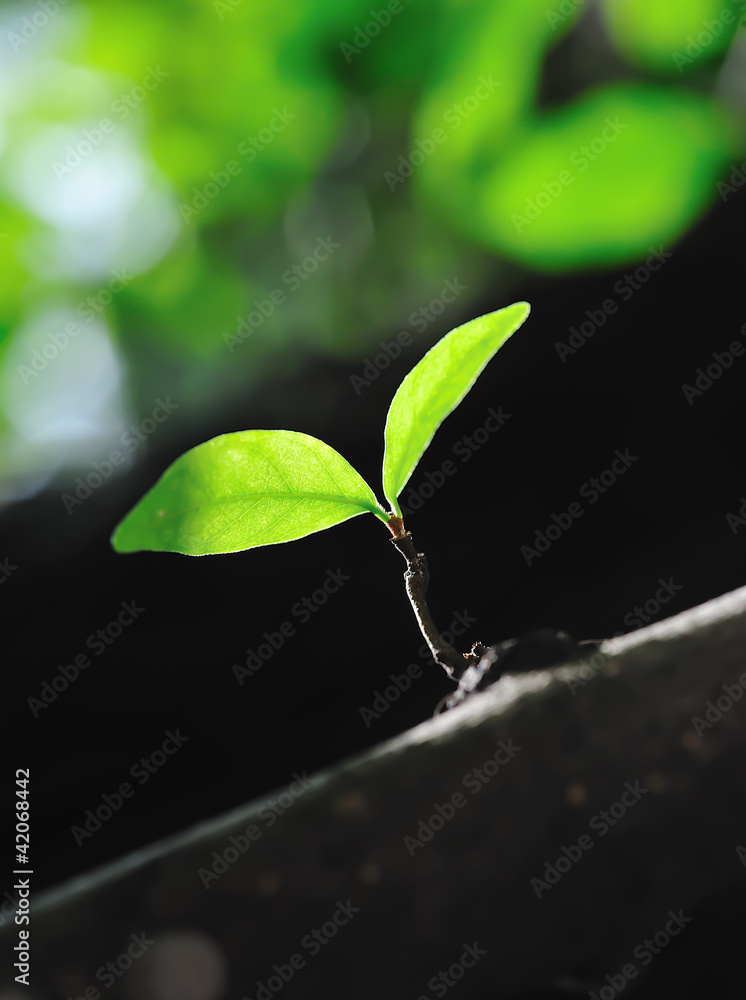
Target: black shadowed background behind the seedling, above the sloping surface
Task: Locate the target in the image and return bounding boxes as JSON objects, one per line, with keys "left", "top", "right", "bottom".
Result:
{"left": 2, "top": 188, "right": 746, "bottom": 888}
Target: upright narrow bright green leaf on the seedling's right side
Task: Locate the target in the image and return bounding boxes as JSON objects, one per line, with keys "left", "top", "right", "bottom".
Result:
{"left": 383, "top": 302, "right": 531, "bottom": 517}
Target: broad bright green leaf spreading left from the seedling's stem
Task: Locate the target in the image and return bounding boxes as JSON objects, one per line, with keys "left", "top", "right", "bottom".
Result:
{"left": 112, "top": 431, "right": 388, "bottom": 556}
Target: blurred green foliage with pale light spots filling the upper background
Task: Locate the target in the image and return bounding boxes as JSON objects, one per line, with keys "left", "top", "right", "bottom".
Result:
{"left": 0, "top": 0, "right": 744, "bottom": 492}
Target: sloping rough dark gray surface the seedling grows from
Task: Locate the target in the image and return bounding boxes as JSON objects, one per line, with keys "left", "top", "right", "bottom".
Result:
{"left": 11, "top": 589, "right": 746, "bottom": 1000}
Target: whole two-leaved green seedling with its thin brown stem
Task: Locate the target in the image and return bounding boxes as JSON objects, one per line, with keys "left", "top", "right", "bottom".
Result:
{"left": 112, "top": 302, "right": 530, "bottom": 678}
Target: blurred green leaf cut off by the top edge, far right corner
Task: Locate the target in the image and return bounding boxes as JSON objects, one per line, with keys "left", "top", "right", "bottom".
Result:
{"left": 601, "top": 0, "right": 744, "bottom": 73}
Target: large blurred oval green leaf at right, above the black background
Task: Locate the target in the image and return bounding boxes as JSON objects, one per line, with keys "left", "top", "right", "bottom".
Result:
{"left": 476, "top": 85, "right": 737, "bottom": 269}
